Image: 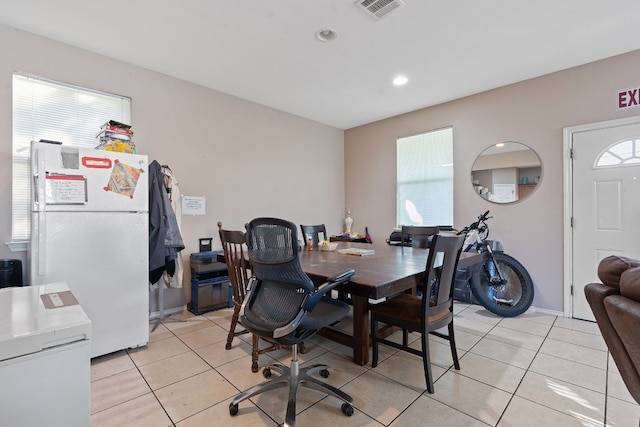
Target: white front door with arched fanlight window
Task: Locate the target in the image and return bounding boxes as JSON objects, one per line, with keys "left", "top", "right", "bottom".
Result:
{"left": 565, "top": 118, "right": 640, "bottom": 320}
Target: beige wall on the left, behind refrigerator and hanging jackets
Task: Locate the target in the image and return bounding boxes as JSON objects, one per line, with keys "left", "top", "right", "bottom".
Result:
{"left": 0, "top": 25, "right": 344, "bottom": 294}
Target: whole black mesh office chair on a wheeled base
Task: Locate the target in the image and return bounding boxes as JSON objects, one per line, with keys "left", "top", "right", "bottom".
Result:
{"left": 229, "top": 218, "right": 354, "bottom": 426}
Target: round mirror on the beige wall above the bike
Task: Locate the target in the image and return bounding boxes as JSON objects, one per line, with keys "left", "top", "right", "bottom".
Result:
{"left": 471, "top": 141, "right": 542, "bottom": 203}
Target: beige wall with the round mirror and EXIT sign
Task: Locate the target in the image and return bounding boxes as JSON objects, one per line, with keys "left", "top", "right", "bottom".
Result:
{"left": 345, "top": 51, "right": 640, "bottom": 311}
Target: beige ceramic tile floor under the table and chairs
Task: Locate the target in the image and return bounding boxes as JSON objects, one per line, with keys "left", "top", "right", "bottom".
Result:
{"left": 91, "top": 304, "right": 640, "bottom": 427}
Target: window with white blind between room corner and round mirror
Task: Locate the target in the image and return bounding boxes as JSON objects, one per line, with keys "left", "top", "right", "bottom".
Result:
{"left": 396, "top": 128, "right": 453, "bottom": 226}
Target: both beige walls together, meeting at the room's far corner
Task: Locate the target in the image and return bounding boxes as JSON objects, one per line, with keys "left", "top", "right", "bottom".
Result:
{"left": 5, "top": 20, "right": 640, "bottom": 311}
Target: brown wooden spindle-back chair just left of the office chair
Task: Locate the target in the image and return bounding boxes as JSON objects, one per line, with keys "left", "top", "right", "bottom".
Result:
{"left": 218, "top": 221, "right": 283, "bottom": 372}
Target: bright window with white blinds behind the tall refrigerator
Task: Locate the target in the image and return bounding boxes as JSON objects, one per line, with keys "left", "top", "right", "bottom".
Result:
{"left": 11, "top": 73, "right": 131, "bottom": 241}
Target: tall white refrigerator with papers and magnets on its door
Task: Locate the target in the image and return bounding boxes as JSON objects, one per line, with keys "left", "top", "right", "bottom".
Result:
{"left": 29, "top": 142, "right": 149, "bottom": 357}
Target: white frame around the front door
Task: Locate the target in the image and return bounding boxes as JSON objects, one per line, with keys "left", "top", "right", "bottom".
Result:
{"left": 562, "top": 116, "right": 640, "bottom": 317}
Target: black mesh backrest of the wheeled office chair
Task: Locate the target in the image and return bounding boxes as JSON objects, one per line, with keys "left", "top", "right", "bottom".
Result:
{"left": 244, "top": 218, "right": 314, "bottom": 338}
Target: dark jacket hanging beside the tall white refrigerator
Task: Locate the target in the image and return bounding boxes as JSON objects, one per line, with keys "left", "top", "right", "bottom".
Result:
{"left": 149, "top": 160, "right": 184, "bottom": 283}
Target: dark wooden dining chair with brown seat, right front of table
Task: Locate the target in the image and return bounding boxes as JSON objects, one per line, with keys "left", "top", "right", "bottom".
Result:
{"left": 370, "top": 234, "right": 464, "bottom": 393}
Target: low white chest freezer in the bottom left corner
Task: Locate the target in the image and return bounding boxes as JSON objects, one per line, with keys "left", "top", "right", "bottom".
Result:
{"left": 0, "top": 282, "right": 91, "bottom": 427}
